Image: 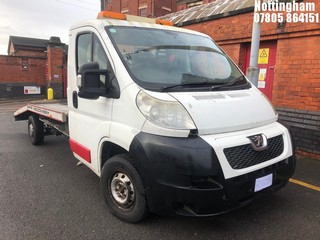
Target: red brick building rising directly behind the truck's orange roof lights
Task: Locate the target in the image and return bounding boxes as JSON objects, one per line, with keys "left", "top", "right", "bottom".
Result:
{"left": 102, "top": 0, "right": 177, "bottom": 18}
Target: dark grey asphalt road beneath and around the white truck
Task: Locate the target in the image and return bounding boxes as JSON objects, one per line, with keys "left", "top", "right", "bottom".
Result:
{"left": 0, "top": 104, "right": 320, "bottom": 240}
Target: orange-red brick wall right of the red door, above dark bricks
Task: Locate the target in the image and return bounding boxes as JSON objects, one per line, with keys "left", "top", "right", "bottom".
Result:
{"left": 273, "top": 36, "right": 320, "bottom": 111}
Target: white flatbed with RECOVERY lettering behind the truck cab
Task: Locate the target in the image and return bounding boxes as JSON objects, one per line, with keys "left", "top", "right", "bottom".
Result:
{"left": 13, "top": 100, "right": 69, "bottom": 123}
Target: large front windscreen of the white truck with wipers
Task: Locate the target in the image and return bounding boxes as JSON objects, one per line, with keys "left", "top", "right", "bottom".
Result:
{"left": 106, "top": 26, "right": 247, "bottom": 91}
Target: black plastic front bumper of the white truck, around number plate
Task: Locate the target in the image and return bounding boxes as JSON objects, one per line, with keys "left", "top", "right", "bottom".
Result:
{"left": 130, "top": 130, "right": 295, "bottom": 216}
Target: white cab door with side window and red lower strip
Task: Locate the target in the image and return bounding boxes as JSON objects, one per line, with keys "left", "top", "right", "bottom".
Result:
{"left": 69, "top": 29, "right": 113, "bottom": 173}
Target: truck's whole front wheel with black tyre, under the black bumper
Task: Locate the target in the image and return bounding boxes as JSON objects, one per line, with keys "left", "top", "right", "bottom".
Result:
{"left": 100, "top": 155, "right": 149, "bottom": 223}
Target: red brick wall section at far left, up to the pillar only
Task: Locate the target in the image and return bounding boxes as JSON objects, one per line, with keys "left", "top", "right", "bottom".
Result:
{"left": 0, "top": 55, "right": 47, "bottom": 98}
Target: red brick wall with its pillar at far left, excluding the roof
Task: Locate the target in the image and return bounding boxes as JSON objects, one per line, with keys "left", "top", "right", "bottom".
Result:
{"left": 0, "top": 44, "right": 67, "bottom": 98}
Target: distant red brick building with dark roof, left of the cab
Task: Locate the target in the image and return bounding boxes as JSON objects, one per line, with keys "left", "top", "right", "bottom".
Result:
{"left": 0, "top": 36, "right": 67, "bottom": 98}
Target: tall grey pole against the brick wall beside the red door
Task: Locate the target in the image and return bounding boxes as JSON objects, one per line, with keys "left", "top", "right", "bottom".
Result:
{"left": 246, "top": 1, "right": 261, "bottom": 87}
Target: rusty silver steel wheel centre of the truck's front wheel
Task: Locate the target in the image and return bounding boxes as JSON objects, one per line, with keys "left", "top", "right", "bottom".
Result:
{"left": 111, "top": 172, "right": 135, "bottom": 209}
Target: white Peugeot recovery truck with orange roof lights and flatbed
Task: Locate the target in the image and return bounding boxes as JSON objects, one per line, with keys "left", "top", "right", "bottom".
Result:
{"left": 14, "top": 11, "right": 295, "bottom": 222}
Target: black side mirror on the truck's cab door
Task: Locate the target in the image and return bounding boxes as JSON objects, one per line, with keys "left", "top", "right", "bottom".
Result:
{"left": 77, "top": 62, "right": 120, "bottom": 99}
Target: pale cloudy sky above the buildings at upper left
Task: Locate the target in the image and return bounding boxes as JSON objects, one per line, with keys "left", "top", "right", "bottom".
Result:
{"left": 0, "top": 0, "right": 100, "bottom": 55}
